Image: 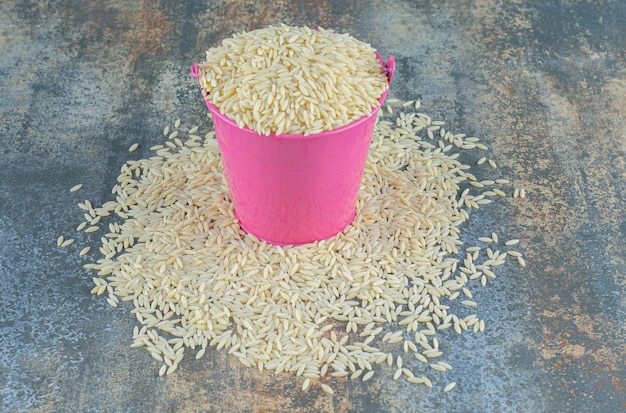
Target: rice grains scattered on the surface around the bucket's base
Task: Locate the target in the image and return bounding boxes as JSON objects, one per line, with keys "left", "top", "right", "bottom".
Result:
{"left": 57, "top": 99, "right": 524, "bottom": 393}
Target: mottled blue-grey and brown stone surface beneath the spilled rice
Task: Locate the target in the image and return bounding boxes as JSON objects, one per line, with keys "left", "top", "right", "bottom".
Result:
{"left": 0, "top": 0, "right": 626, "bottom": 412}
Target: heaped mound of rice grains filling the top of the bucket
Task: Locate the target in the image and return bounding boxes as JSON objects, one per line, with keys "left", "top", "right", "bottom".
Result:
{"left": 199, "top": 25, "right": 389, "bottom": 135}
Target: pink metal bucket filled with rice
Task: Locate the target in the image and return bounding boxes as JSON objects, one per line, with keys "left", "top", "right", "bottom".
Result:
{"left": 191, "top": 53, "right": 395, "bottom": 245}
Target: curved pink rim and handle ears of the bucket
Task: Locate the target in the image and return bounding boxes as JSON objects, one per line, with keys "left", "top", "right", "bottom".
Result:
{"left": 191, "top": 51, "right": 396, "bottom": 140}
